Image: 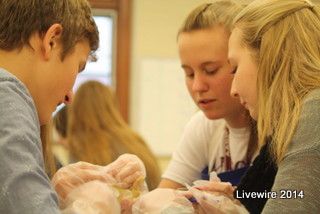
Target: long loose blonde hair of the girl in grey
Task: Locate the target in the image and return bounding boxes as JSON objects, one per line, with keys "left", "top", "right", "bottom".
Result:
{"left": 235, "top": 0, "right": 320, "bottom": 164}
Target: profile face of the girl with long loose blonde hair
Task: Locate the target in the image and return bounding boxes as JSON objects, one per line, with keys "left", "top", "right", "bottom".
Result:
{"left": 228, "top": 28, "right": 258, "bottom": 120}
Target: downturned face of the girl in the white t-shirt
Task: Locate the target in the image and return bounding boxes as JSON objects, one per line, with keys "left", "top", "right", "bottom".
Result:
{"left": 178, "top": 26, "right": 245, "bottom": 126}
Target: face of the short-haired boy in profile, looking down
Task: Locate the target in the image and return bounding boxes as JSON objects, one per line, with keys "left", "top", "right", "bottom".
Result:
{"left": 36, "top": 40, "right": 90, "bottom": 124}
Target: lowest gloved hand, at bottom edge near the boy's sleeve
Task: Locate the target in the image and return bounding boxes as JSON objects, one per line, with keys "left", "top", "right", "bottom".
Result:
{"left": 62, "top": 181, "right": 121, "bottom": 214}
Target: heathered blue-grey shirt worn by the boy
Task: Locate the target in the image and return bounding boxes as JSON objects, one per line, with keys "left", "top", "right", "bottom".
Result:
{"left": 0, "top": 68, "right": 60, "bottom": 214}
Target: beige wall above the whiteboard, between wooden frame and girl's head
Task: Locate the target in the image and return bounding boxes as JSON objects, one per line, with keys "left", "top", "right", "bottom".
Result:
{"left": 132, "top": 0, "right": 252, "bottom": 57}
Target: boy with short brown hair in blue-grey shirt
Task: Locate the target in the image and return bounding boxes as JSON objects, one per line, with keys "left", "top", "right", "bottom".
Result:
{"left": 0, "top": 0, "right": 99, "bottom": 214}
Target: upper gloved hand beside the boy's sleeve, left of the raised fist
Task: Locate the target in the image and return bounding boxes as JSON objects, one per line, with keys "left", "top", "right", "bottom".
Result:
{"left": 51, "top": 162, "right": 115, "bottom": 208}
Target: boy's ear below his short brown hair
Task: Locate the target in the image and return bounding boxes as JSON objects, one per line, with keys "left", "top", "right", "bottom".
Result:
{"left": 42, "top": 24, "right": 63, "bottom": 60}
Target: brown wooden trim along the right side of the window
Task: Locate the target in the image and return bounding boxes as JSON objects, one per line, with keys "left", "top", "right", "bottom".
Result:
{"left": 89, "top": 0, "right": 132, "bottom": 122}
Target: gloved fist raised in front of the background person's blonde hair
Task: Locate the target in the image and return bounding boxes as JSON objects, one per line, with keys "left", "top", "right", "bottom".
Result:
{"left": 105, "top": 154, "right": 146, "bottom": 188}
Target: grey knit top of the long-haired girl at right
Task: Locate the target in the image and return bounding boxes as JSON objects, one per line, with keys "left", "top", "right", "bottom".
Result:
{"left": 262, "top": 89, "right": 320, "bottom": 214}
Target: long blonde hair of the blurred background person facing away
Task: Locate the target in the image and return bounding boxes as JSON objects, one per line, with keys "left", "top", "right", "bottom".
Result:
{"left": 67, "top": 81, "right": 160, "bottom": 189}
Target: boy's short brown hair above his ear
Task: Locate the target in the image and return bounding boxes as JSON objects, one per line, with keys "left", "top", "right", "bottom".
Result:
{"left": 0, "top": 0, "right": 99, "bottom": 60}
